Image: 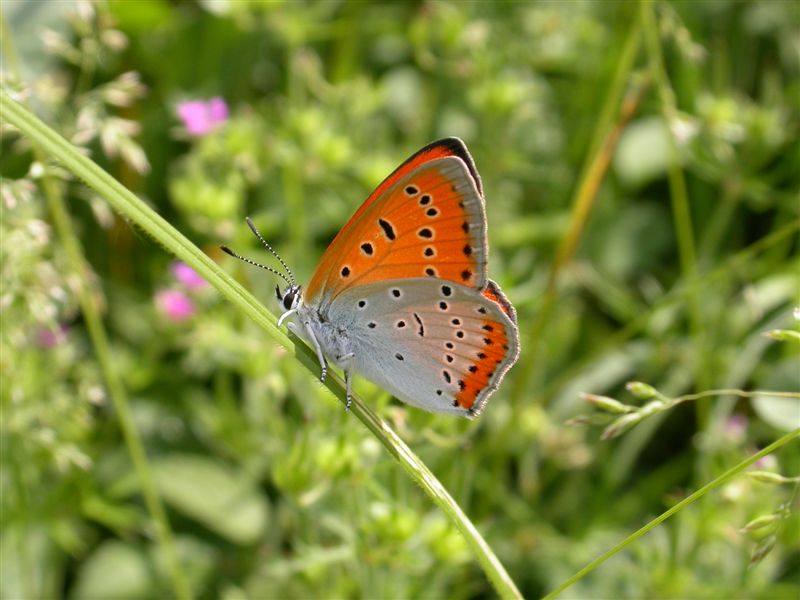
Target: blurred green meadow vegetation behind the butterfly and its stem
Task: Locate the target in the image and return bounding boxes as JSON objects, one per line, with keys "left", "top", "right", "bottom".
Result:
{"left": 0, "top": 0, "right": 800, "bottom": 600}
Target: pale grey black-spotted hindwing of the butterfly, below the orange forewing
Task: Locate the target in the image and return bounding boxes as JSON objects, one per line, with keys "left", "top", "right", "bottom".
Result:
{"left": 326, "top": 278, "right": 519, "bottom": 416}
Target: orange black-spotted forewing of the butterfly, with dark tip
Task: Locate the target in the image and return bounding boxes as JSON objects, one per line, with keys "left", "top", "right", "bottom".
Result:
{"left": 306, "top": 140, "right": 487, "bottom": 304}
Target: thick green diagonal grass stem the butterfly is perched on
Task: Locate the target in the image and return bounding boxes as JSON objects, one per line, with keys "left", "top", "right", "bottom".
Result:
{"left": 0, "top": 90, "right": 522, "bottom": 598}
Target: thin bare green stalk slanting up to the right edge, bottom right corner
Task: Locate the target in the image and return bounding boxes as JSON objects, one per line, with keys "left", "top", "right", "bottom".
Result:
{"left": 543, "top": 428, "right": 800, "bottom": 600}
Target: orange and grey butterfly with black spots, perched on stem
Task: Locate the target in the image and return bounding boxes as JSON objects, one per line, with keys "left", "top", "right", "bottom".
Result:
{"left": 222, "top": 137, "right": 519, "bottom": 417}
